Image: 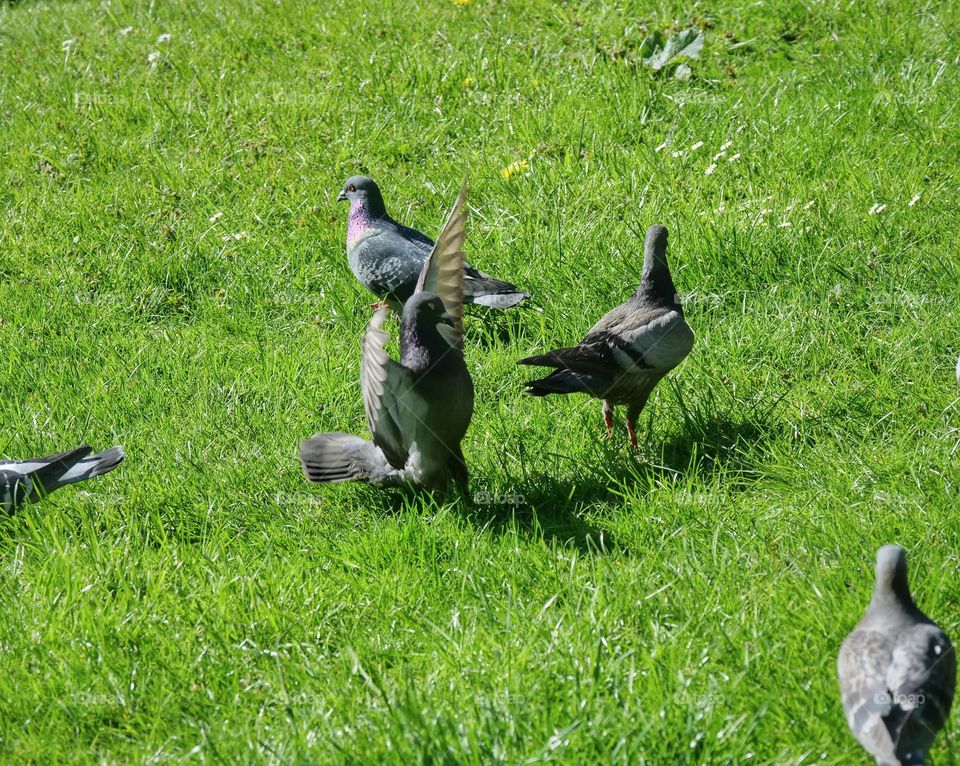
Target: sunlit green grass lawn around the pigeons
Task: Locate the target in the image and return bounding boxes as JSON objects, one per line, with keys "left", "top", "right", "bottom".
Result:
{"left": 0, "top": 0, "right": 960, "bottom": 766}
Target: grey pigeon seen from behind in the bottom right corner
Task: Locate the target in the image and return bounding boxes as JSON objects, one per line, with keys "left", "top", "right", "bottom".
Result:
{"left": 837, "top": 545, "right": 957, "bottom": 766}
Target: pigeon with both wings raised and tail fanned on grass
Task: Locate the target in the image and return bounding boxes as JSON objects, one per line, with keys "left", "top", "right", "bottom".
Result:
{"left": 300, "top": 187, "right": 473, "bottom": 491}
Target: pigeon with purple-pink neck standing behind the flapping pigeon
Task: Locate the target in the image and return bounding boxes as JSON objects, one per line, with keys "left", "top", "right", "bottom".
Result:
{"left": 337, "top": 176, "right": 529, "bottom": 313}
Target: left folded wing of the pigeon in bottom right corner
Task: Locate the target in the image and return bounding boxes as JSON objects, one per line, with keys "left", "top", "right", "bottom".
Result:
{"left": 837, "top": 630, "right": 897, "bottom": 763}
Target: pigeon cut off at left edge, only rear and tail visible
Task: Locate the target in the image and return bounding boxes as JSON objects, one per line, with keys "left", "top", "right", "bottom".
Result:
{"left": 0, "top": 444, "right": 124, "bottom": 513}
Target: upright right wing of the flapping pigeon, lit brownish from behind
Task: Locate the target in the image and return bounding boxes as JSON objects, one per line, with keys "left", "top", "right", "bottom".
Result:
{"left": 416, "top": 184, "right": 467, "bottom": 348}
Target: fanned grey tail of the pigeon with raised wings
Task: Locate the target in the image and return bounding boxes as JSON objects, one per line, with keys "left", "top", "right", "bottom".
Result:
{"left": 300, "top": 433, "right": 397, "bottom": 484}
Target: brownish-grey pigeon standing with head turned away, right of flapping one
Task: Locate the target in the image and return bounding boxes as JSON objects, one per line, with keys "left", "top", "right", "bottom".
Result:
{"left": 517, "top": 226, "right": 693, "bottom": 447}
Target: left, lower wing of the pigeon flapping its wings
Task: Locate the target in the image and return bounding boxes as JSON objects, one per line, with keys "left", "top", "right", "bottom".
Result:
{"left": 360, "top": 308, "right": 411, "bottom": 468}
